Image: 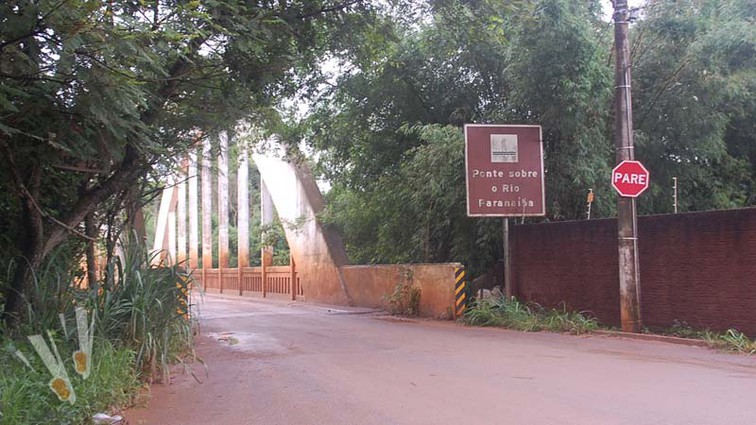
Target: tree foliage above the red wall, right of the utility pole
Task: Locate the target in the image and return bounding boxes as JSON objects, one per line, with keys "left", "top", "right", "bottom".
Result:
{"left": 633, "top": 0, "right": 756, "bottom": 213}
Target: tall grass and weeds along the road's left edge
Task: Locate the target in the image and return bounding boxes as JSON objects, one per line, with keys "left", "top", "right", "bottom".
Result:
{"left": 0, "top": 237, "right": 193, "bottom": 424}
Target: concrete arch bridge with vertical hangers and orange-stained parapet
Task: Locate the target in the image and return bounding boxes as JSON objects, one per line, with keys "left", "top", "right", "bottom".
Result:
{"left": 153, "top": 133, "right": 464, "bottom": 319}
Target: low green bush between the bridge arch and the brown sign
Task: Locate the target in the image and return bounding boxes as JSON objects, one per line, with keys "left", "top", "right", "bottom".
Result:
{"left": 321, "top": 125, "right": 501, "bottom": 271}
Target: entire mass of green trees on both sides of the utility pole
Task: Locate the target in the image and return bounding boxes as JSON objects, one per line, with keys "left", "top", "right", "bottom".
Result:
{"left": 295, "top": 0, "right": 756, "bottom": 275}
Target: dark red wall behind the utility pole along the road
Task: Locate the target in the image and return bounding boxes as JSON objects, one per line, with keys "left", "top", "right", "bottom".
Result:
{"left": 512, "top": 208, "right": 756, "bottom": 336}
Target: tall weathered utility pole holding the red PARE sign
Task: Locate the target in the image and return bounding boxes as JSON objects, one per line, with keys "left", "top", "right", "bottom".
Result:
{"left": 613, "top": 0, "right": 643, "bottom": 332}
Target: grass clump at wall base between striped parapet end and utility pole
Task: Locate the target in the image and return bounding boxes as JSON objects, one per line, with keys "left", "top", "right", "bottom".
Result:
{"left": 464, "top": 296, "right": 598, "bottom": 334}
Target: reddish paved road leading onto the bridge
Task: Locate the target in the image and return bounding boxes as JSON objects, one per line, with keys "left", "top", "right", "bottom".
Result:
{"left": 126, "top": 297, "right": 756, "bottom": 425}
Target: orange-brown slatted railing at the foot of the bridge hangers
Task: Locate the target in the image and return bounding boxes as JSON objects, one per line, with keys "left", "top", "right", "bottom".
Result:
{"left": 192, "top": 266, "right": 304, "bottom": 300}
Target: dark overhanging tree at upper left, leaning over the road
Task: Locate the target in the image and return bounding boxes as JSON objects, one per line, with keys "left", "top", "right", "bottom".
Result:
{"left": 0, "top": 0, "right": 372, "bottom": 321}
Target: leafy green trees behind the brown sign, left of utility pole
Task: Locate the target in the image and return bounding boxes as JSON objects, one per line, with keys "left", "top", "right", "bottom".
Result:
{"left": 296, "top": 0, "right": 614, "bottom": 270}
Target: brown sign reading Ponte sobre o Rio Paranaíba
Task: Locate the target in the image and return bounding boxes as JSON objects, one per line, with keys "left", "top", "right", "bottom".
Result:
{"left": 465, "top": 124, "right": 546, "bottom": 217}
